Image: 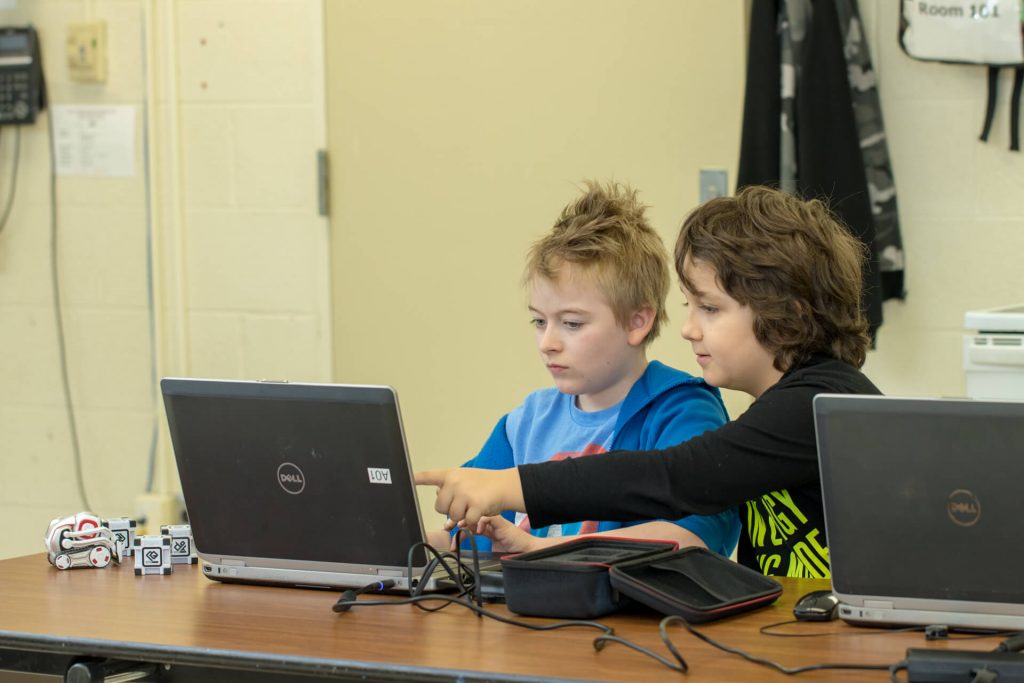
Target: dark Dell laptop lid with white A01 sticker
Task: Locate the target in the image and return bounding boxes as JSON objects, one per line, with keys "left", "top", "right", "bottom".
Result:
{"left": 161, "top": 379, "right": 423, "bottom": 567}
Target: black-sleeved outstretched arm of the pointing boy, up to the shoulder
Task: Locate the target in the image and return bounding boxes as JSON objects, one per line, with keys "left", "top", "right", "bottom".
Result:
{"left": 520, "top": 359, "right": 879, "bottom": 525}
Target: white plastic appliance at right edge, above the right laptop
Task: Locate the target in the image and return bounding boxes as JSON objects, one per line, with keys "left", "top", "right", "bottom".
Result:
{"left": 964, "top": 304, "right": 1024, "bottom": 399}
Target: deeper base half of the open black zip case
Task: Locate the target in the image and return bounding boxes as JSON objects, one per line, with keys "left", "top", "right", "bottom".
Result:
{"left": 502, "top": 537, "right": 679, "bottom": 618}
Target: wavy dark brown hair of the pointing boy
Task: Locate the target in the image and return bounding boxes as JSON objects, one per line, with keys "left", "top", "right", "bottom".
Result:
{"left": 676, "top": 185, "right": 869, "bottom": 372}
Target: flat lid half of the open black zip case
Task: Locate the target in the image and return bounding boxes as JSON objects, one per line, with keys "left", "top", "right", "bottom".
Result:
{"left": 609, "top": 548, "right": 782, "bottom": 624}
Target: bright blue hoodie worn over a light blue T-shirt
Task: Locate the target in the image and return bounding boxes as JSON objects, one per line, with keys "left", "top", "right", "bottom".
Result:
{"left": 464, "top": 360, "right": 740, "bottom": 555}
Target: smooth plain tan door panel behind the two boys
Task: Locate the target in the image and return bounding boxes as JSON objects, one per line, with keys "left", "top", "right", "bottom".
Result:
{"left": 326, "top": 0, "right": 746, "bottom": 525}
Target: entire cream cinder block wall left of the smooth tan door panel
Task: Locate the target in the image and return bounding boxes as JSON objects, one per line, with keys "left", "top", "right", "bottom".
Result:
{"left": 0, "top": 0, "right": 331, "bottom": 557}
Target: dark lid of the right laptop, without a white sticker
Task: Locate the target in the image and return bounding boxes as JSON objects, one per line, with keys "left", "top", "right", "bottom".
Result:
{"left": 814, "top": 395, "right": 1024, "bottom": 603}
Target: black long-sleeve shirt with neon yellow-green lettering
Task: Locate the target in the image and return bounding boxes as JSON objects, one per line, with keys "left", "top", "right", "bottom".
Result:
{"left": 519, "top": 356, "right": 881, "bottom": 577}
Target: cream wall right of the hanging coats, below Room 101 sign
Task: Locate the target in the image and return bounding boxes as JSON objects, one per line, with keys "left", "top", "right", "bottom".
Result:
{"left": 860, "top": 0, "right": 1024, "bottom": 396}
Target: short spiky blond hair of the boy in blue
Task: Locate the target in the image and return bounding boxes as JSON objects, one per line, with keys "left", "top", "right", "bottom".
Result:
{"left": 522, "top": 180, "right": 672, "bottom": 344}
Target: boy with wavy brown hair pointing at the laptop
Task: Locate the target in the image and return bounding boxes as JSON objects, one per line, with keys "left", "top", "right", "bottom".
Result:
{"left": 417, "top": 187, "right": 880, "bottom": 577}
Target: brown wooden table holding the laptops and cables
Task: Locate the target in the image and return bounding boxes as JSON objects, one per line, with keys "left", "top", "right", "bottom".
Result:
{"left": 0, "top": 555, "right": 998, "bottom": 683}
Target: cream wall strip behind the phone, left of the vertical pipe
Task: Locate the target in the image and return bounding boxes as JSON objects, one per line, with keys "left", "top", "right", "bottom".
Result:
{"left": 0, "top": 0, "right": 156, "bottom": 556}
